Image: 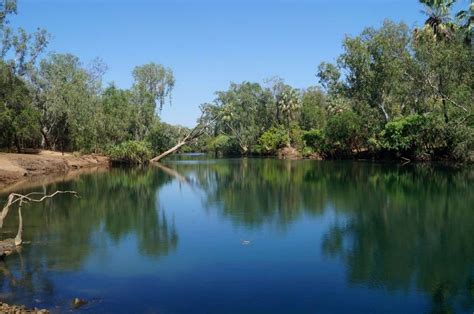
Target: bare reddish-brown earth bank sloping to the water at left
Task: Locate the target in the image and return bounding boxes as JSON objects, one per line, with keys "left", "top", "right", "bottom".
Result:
{"left": 0, "top": 151, "right": 109, "bottom": 190}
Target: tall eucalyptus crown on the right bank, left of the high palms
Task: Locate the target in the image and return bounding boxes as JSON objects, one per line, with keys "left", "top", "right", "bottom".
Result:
{"left": 338, "top": 21, "right": 411, "bottom": 122}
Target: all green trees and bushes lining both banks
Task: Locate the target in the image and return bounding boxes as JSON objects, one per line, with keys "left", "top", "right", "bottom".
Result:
{"left": 0, "top": 0, "right": 474, "bottom": 162}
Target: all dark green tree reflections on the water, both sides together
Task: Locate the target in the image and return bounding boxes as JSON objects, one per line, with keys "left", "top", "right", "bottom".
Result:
{"left": 0, "top": 159, "right": 474, "bottom": 313}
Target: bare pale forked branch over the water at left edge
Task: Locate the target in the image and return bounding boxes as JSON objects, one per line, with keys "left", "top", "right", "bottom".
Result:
{"left": 0, "top": 191, "right": 78, "bottom": 257}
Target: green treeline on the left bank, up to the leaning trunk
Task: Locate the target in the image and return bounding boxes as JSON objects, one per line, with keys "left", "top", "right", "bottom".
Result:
{"left": 0, "top": 0, "right": 184, "bottom": 160}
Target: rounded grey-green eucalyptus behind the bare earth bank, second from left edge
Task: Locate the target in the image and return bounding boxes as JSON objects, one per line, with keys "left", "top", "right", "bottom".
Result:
{"left": 35, "top": 54, "right": 98, "bottom": 150}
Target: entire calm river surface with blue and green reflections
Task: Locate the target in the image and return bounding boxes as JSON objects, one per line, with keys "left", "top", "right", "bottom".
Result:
{"left": 0, "top": 156, "right": 474, "bottom": 313}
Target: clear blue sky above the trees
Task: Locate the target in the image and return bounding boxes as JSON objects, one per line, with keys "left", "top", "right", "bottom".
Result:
{"left": 12, "top": 0, "right": 469, "bottom": 126}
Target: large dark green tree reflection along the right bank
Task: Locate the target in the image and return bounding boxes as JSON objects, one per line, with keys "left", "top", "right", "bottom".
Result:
{"left": 168, "top": 159, "right": 474, "bottom": 312}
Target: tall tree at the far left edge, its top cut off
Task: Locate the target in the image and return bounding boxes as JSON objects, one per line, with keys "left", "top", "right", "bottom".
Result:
{"left": 0, "top": 0, "right": 49, "bottom": 151}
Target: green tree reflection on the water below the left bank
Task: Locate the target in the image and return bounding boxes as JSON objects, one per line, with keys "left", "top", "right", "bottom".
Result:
{"left": 0, "top": 169, "right": 178, "bottom": 308}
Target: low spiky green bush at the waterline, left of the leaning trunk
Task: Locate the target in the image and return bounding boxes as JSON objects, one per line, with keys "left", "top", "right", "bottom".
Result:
{"left": 107, "top": 141, "right": 152, "bottom": 164}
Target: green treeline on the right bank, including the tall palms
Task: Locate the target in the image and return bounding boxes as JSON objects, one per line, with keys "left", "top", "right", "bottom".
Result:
{"left": 198, "top": 0, "right": 474, "bottom": 160}
